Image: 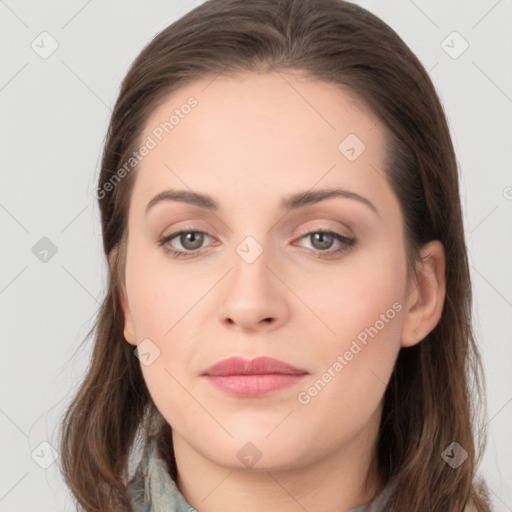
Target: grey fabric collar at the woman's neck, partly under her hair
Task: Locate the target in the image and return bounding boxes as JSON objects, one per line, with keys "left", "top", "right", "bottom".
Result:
{"left": 128, "top": 441, "right": 394, "bottom": 512}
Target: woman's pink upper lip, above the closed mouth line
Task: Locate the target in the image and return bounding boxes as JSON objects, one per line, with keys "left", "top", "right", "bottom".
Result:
{"left": 203, "top": 357, "right": 308, "bottom": 375}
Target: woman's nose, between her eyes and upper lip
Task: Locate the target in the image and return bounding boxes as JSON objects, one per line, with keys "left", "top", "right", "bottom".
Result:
{"left": 219, "top": 243, "right": 290, "bottom": 332}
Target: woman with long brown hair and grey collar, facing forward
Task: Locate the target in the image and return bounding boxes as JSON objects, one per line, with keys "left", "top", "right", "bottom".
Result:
{"left": 61, "top": 0, "right": 489, "bottom": 512}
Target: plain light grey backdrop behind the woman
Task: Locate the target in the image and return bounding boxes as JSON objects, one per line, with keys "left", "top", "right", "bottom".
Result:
{"left": 0, "top": 0, "right": 512, "bottom": 512}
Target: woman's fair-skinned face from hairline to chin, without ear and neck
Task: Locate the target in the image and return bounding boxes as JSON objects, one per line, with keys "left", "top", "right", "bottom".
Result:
{"left": 123, "top": 72, "right": 416, "bottom": 469}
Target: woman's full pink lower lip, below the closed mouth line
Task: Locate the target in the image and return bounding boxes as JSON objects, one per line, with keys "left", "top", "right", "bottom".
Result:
{"left": 206, "top": 373, "right": 306, "bottom": 397}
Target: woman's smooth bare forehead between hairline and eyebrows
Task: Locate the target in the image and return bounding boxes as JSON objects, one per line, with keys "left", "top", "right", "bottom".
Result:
{"left": 133, "top": 71, "right": 394, "bottom": 216}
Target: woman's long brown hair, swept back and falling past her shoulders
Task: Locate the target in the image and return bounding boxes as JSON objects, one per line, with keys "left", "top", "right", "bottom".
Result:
{"left": 61, "top": 0, "right": 489, "bottom": 512}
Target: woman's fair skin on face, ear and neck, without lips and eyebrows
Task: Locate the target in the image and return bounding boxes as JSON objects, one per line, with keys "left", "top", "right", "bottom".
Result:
{"left": 111, "top": 71, "right": 445, "bottom": 512}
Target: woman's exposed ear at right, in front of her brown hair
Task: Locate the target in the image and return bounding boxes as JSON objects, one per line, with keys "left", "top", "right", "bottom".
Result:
{"left": 401, "top": 240, "right": 446, "bottom": 347}
